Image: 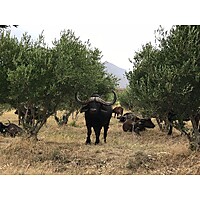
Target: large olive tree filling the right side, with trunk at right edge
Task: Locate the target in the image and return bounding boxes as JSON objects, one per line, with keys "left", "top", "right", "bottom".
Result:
{"left": 127, "top": 26, "right": 200, "bottom": 149}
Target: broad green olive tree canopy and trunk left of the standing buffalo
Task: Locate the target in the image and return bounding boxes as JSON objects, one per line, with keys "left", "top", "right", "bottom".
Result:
{"left": 0, "top": 30, "right": 116, "bottom": 138}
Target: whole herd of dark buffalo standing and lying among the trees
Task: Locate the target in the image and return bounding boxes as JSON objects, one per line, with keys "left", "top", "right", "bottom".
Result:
{"left": 0, "top": 91, "right": 200, "bottom": 144}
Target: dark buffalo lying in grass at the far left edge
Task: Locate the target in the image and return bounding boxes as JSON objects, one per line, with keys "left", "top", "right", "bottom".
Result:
{"left": 0, "top": 122, "right": 23, "bottom": 137}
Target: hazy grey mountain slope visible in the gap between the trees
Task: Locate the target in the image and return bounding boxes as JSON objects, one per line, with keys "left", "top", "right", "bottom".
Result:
{"left": 104, "top": 61, "right": 128, "bottom": 88}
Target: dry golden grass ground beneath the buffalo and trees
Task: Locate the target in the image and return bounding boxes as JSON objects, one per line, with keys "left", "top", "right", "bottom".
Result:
{"left": 0, "top": 111, "right": 200, "bottom": 175}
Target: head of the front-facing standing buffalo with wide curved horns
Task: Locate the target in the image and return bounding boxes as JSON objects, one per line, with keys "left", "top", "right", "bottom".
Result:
{"left": 75, "top": 91, "right": 117, "bottom": 114}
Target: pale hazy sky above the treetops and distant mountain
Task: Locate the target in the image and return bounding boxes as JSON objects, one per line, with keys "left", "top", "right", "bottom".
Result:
{"left": 12, "top": 23, "right": 170, "bottom": 70}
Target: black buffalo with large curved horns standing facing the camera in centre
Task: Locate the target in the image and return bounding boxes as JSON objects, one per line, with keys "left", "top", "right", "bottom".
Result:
{"left": 75, "top": 91, "right": 117, "bottom": 144}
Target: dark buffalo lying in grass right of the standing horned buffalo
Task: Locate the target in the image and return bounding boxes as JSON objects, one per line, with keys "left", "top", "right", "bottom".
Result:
{"left": 122, "top": 118, "right": 155, "bottom": 135}
